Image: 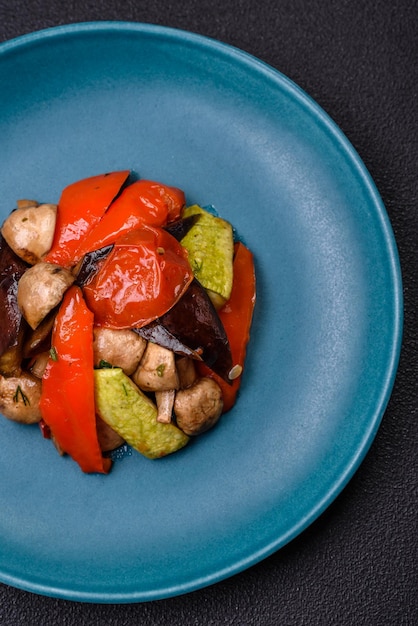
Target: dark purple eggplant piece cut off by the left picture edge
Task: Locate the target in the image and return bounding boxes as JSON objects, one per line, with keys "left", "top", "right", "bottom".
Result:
{"left": 0, "top": 235, "right": 29, "bottom": 375}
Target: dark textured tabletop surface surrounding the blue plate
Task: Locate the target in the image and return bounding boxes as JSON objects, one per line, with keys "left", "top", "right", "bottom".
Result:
{"left": 0, "top": 0, "right": 418, "bottom": 626}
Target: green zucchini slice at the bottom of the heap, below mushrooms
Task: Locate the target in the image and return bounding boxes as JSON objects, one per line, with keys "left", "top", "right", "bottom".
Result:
{"left": 94, "top": 368, "right": 189, "bottom": 459}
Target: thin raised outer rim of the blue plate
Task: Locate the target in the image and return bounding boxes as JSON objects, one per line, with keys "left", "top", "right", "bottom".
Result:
{"left": 0, "top": 20, "right": 404, "bottom": 604}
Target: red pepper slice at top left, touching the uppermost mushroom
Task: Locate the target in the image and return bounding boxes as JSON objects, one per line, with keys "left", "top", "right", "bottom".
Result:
{"left": 44, "top": 170, "right": 130, "bottom": 267}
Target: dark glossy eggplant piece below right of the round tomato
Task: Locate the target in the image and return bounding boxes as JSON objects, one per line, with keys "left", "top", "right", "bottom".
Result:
{"left": 133, "top": 279, "right": 232, "bottom": 384}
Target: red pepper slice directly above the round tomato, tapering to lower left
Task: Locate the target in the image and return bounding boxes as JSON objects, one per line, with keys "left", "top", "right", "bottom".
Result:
{"left": 74, "top": 180, "right": 186, "bottom": 256}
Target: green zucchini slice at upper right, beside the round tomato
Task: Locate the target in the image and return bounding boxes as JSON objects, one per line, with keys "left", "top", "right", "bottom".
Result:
{"left": 181, "top": 204, "right": 234, "bottom": 302}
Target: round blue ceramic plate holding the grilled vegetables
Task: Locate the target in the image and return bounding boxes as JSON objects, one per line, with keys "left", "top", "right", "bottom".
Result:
{"left": 0, "top": 22, "right": 402, "bottom": 603}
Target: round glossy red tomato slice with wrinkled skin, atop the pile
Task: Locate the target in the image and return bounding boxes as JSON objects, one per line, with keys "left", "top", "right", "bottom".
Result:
{"left": 84, "top": 225, "right": 193, "bottom": 328}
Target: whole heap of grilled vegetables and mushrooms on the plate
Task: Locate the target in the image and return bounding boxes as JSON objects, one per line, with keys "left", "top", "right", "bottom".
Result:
{"left": 0, "top": 170, "right": 255, "bottom": 473}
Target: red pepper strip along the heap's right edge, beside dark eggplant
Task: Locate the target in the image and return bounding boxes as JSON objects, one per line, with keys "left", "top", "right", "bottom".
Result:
{"left": 197, "top": 243, "right": 256, "bottom": 413}
